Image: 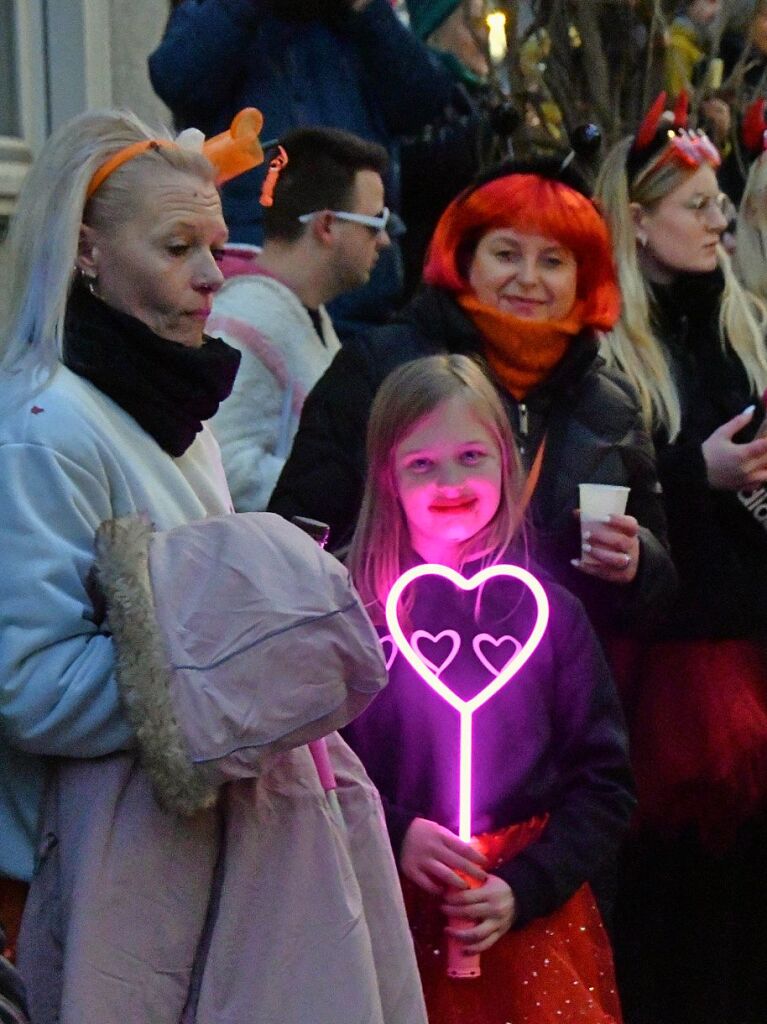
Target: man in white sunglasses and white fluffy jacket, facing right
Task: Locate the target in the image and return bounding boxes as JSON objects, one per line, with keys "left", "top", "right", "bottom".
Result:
{"left": 207, "top": 128, "right": 390, "bottom": 512}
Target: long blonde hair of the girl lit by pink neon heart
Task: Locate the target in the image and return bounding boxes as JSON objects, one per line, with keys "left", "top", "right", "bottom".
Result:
{"left": 348, "top": 355, "right": 522, "bottom": 620}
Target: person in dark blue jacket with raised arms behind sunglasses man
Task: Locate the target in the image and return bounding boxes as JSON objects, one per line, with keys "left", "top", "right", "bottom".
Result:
{"left": 150, "top": 0, "right": 455, "bottom": 337}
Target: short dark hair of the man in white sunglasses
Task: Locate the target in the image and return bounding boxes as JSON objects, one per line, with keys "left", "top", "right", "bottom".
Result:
{"left": 263, "top": 128, "right": 388, "bottom": 242}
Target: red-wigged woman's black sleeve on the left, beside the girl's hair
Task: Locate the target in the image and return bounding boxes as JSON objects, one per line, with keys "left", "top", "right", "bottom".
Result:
{"left": 268, "top": 343, "right": 377, "bottom": 550}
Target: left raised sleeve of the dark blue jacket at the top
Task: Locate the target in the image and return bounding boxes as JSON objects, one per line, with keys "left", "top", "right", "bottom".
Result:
{"left": 150, "top": 0, "right": 264, "bottom": 121}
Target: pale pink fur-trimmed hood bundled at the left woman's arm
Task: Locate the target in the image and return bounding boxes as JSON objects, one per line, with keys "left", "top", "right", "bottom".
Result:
{"left": 96, "top": 513, "right": 386, "bottom": 814}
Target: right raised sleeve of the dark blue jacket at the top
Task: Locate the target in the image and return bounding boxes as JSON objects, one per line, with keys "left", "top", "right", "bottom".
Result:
{"left": 335, "top": 0, "right": 454, "bottom": 135}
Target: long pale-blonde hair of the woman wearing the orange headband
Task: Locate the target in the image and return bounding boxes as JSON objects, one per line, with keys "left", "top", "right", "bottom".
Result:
{"left": 0, "top": 111, "right": 215, "bottom": 375}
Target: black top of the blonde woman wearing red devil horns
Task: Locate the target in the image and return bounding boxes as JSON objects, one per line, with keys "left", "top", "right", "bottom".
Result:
{"left": 655, "top": 270, "right": 767, "bottom": 639}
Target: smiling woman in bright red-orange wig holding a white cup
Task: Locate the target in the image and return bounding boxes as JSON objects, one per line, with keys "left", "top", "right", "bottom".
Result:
{"left": 269, "top": 159, "right": 675, "bottom": 633}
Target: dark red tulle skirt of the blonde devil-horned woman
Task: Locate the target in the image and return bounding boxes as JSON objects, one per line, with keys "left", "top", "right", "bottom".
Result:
{"left": 610, "top": 639, "right": 767, "bottom": 849}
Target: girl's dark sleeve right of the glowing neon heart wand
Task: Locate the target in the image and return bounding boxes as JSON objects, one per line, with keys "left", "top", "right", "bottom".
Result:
{"left": 497, "top": 600, "right": 635, "bottom": 928}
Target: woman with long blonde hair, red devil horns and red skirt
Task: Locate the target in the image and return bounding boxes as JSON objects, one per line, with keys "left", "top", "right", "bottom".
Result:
{"left": 597, "top": 95, "right": 767, "bottom": 1024}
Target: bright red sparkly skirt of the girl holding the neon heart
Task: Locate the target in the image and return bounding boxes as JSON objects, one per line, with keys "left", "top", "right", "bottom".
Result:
{"left": 403, "top": 818, "right": 623, "bottom": 1024}
